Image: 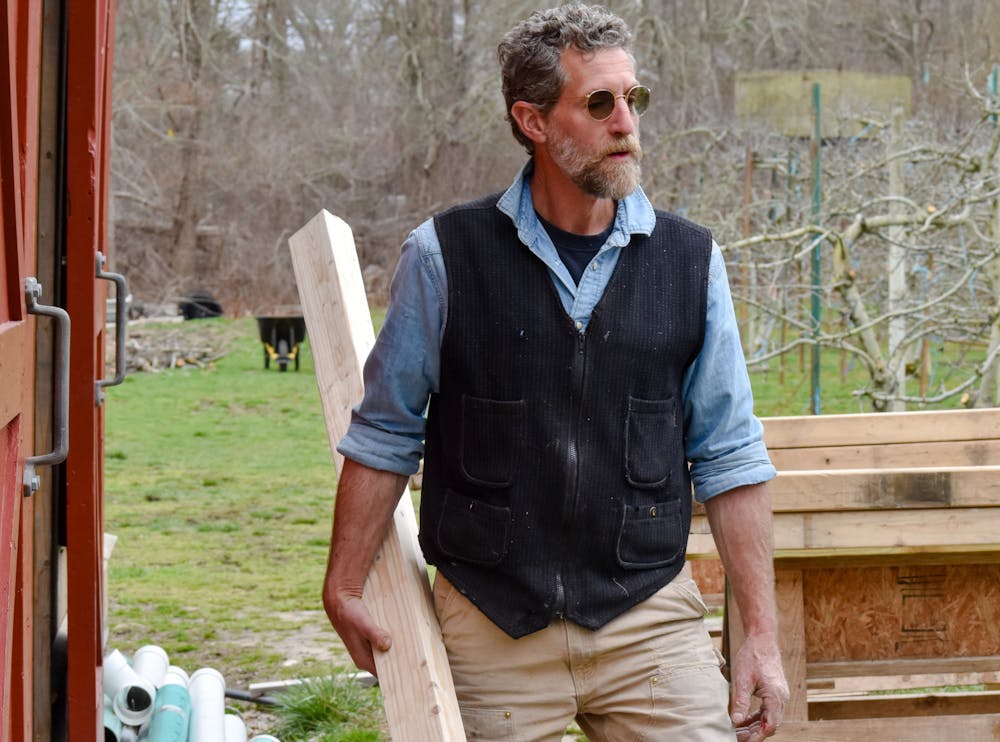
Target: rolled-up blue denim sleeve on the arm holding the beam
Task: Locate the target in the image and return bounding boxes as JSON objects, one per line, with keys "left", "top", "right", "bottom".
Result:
{"left": 337, "top": 220, "right": 446, "bottom": 474}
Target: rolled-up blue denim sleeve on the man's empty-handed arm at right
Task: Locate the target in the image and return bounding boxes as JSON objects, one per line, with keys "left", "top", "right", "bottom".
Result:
{"left": 682, "top": 245, "right": 776, "bottom": 502}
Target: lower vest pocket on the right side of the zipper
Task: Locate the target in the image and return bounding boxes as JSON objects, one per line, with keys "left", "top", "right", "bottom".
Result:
{"left": 617, "top": 500, "right": 686, "bottom": 569}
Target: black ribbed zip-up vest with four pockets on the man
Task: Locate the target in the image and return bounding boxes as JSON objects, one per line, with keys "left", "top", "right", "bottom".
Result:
{"left": 420, "top": 195, "right": 711, "bottom": 637}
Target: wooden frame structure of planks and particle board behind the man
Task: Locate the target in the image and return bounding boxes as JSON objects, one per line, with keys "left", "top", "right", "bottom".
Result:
{"left": 689, "top": 409, "right": 1000, "bottom": 742}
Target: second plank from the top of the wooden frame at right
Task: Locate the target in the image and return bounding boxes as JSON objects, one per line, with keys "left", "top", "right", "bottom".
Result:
{"left": 768, "top": 438, "right": 1000, "bottom": 472}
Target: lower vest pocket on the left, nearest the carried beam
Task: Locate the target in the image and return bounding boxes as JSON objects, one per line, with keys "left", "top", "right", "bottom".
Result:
{"left": 437, "top": 490, "right": 510, "bottom": 566}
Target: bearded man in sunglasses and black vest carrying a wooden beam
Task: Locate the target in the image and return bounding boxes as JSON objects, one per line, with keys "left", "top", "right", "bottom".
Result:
{"left": 323, "top": 5, "right": 788, "bottom": 742}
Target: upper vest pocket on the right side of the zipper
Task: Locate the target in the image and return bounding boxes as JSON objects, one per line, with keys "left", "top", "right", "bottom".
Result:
{"left": 625, "top": 396, "right": 679, "bottom": 489}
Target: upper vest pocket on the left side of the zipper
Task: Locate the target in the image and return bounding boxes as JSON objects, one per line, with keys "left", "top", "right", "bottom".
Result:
{"left": 459, "top": 395, "right": 525, "bottom": 487}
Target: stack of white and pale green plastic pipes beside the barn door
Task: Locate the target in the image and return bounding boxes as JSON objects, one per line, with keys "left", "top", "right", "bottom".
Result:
{"left": 104, "top": 644, "right": 278, "bottom": 742}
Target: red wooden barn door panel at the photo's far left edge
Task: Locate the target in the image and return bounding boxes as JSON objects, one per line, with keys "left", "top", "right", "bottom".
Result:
{"left": 0, "top": 0, "right": 41, "bottom": 740}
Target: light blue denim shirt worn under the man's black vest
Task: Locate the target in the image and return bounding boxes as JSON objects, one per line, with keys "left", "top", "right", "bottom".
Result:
{"left": 337, "top": 162, "right": 775, "bottom": 502}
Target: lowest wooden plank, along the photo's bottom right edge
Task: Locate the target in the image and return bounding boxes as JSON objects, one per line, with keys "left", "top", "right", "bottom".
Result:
{"left": 770, "top": 714, "right": 1000, "bottom": 742}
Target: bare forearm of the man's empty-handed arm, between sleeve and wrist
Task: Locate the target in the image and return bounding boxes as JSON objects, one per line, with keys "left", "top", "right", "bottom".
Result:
{"left": 705, "top": 484, "right": 777, "bottom": 635}
